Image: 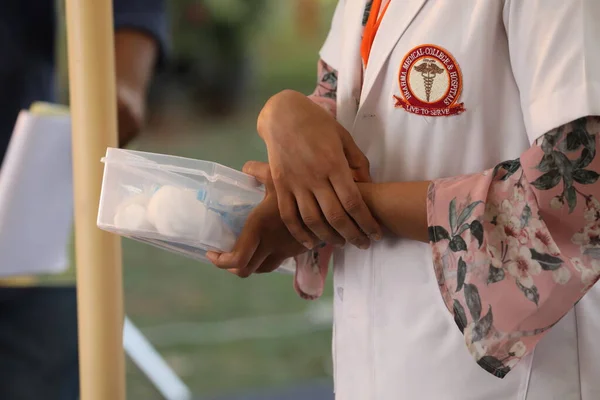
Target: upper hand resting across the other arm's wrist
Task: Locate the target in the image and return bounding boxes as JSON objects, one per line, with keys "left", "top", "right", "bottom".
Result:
{"left": 257, "top": 91, "right": 381, "bottom": 249}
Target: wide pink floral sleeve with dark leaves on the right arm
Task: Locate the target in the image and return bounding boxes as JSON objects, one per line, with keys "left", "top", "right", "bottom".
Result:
{"left": 428, "top": 117, "right": 600, "bottom": 377}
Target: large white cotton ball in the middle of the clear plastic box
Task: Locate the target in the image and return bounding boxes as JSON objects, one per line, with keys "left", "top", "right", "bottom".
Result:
{"left": 147, "top": 186, "right": 236, "bottom": 250}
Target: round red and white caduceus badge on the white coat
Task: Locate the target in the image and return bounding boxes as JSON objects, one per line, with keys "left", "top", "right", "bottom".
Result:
{"left": 394, "top": 44, "right": 465, "bottom": 117}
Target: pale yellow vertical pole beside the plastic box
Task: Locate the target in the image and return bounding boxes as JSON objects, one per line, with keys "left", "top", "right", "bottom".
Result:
{"left": 66, "top": 0, "right": 125, "bottom": 400}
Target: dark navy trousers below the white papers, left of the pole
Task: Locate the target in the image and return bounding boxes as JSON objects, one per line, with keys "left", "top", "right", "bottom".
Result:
{"left": 0, "top": 287, "right": 79, "bottom": 400}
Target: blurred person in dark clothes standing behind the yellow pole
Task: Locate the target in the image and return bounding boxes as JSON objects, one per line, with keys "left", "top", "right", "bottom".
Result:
{"left": 0, "top": 0, "right": 167, "bottom": 400}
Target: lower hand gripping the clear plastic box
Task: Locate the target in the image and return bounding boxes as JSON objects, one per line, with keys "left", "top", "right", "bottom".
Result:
{"left": 207, "top": 161, "right": 307, "bottom": 278}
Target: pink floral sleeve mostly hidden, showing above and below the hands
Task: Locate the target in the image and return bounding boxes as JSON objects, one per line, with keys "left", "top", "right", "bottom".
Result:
{"left": 294, "top": 60, "right": 337, "bottom": 300}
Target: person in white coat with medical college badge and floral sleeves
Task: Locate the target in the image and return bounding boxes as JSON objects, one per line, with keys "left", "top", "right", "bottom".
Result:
{"left": 209, "top": 0, "right": 600, "bottom": 400}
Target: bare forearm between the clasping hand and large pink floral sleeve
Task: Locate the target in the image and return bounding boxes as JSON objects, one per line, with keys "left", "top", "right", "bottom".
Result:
{"left": 358, "top": 181, "right": 431, "bottom": 243}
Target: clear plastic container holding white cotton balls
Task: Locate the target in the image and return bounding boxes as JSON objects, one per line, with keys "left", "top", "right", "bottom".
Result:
{"left": 98, "top": 148, "right": 265, "bottom": 261}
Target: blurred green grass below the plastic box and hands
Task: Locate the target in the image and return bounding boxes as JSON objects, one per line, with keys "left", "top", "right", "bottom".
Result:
{"left": 124, "top": 240, "right": 331, "bottom": 399}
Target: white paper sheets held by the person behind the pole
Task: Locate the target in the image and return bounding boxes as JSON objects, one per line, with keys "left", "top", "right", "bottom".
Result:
{"left": 0, "top": 111, "right": 73, "bottom": 276}
